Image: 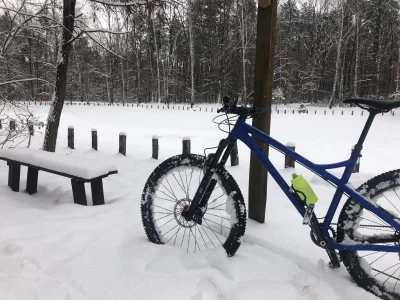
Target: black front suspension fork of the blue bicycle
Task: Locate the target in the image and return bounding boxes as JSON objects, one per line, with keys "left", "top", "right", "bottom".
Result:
{"left": 182, "top": 137, "right": 236, "bottom": 225}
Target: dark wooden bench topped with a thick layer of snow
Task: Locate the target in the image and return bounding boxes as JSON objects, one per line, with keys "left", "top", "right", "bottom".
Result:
{"left": 0, "top": 148, "right": 118, "bottom": 205}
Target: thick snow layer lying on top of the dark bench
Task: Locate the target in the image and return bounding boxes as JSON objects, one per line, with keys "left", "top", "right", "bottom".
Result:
{"left": 0, "top": 148, "right": 117, "bottom": 180}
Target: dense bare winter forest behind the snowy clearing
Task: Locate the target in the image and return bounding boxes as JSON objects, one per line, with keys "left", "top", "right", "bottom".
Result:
{"left": 0, "top": 0, "right": 400, "bottom": 105}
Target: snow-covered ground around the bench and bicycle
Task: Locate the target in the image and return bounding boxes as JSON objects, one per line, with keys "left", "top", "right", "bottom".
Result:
{"left": 0, "top": 106, "right": 400, "bottom": 300}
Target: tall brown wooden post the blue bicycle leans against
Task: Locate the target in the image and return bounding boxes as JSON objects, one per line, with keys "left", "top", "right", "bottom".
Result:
{"left": 249, "top": 0, "right": 278, "bottom": 223}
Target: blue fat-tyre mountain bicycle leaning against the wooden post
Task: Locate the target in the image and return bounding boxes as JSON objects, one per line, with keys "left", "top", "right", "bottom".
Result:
{"left": 141, "top": 97, "right": 400, "bottom": 299}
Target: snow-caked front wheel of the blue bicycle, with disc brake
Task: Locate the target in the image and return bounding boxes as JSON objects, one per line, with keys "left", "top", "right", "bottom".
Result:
{"left": 141, "top": 154, "right": 246, "bottom": 256}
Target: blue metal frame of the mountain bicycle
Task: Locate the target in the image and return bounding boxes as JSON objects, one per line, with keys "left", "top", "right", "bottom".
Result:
{"left": 229, "top": 120, "right": 400, "bottom": 252}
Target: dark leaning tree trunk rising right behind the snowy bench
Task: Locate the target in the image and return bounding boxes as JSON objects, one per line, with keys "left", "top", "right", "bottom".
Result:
{"left": 43, "top": 0, "right": 76, "bottom": 152}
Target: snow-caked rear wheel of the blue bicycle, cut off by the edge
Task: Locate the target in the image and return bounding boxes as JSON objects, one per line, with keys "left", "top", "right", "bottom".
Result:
{"left": 338, "top": 170, "right": 400, "bottom": 299}
